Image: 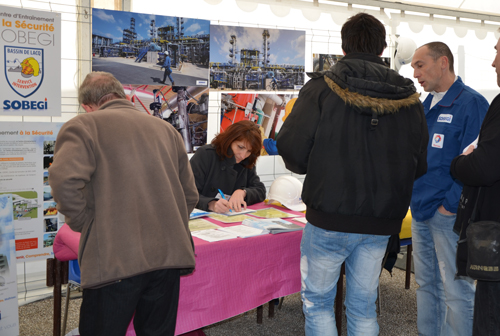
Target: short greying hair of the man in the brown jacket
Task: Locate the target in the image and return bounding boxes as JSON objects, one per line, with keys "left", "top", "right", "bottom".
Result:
{"left": 78, "top": 71, "right": 127, "bottom": 106}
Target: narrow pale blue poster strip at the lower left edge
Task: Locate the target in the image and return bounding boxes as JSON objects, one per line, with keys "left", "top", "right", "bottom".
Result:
{"left": 0, "top": 195, "right": 19, "bottom": 336}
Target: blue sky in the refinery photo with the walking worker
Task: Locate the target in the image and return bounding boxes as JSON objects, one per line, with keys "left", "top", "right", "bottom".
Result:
{"left": 92, "top": 8, "right": 210, "bottom": 42}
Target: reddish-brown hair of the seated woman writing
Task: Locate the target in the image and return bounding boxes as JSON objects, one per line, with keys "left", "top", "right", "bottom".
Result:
{"left": 212, "top": 120, "right": 262, "bottom": 169}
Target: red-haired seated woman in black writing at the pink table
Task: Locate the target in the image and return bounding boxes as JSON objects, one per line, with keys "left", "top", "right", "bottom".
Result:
{"left": 191, "top": 120, "right": 266, "bottom": 213}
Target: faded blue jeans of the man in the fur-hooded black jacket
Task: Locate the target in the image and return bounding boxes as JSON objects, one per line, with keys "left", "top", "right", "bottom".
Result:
{"left": 300, "top": 223, "right": 389, "bottom": 336}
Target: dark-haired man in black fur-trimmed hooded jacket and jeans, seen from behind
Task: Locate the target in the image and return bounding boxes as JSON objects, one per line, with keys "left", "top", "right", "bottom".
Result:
{"left": 277, "top": 13, "right": 428, "bottom": 336}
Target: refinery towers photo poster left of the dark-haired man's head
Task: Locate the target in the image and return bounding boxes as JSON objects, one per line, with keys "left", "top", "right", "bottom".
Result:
{"left": 210, "top": 25, "right": 306, "bottom": 91}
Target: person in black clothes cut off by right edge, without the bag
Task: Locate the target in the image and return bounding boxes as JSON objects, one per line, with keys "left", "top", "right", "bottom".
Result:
{"left": 451, "top": 34, "right": 500, "bottom": 336}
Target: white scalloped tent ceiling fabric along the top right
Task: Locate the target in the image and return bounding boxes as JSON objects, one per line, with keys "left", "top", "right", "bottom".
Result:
{"left": 227, "top": 0, "right": 500, "bottom": 40}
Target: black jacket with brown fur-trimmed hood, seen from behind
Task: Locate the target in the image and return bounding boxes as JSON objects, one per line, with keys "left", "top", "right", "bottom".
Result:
{"left": 277, "top": 53, "right": 428, "bottom": 235}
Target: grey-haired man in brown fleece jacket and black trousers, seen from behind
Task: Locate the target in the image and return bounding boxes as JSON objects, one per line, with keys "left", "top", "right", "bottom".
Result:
{"left": 49, "top": 72, "right": 198, "bottom": 336}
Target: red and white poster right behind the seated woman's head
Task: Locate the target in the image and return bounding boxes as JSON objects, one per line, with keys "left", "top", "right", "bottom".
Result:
{"left": 220, "top": 92, "right": 298, "bottom": 155}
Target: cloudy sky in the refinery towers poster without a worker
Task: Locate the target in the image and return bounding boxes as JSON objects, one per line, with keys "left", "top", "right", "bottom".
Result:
{"left": 210, "top": 25, "right": 306, "bottom": 65}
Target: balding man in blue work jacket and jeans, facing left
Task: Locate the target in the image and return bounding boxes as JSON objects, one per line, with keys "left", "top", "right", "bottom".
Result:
{"left": 410, "top": 42, "right": 488, "bottom": 336}
